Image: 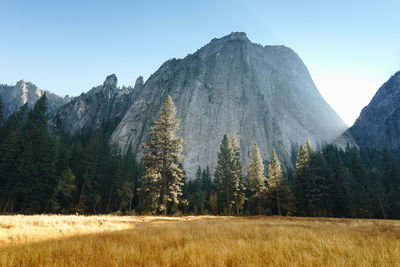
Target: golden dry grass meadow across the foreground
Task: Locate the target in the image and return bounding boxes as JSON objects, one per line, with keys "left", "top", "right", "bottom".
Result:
{"left": 0, "top": 215, "right": 400, "bottom": 266}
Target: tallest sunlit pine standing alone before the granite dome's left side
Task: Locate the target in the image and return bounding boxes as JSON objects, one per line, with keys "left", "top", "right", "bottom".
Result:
{"left": 143, "top": 96, "right": 184, "bottom": 215}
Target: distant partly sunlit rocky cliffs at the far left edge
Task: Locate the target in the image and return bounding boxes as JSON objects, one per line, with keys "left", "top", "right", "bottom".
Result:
{"left": 0, "top": 80, "right": 69, "bottom": 118}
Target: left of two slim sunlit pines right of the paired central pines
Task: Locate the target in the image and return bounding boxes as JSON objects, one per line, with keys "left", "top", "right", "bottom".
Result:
{"left": 247, "top": 143, "right": 267, "bottom": 214}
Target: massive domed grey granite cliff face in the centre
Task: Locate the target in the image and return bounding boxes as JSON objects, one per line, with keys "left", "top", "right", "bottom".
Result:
{"left": 112, "top": 33, "right": 346, "bottom": 178}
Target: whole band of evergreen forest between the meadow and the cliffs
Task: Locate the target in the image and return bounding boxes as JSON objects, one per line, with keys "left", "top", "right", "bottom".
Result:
{"left": 0, "top": 95, "right": 400, "bottom": 219}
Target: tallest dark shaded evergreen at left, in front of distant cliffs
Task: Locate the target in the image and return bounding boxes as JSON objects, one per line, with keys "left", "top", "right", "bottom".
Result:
{"left": 17, "top": 94, "right": 56, "bottom": 213}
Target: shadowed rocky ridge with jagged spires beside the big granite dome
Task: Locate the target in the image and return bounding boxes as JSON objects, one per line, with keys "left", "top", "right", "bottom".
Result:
{"left": 49, "top": 74, "right": 143, "bottom": 134}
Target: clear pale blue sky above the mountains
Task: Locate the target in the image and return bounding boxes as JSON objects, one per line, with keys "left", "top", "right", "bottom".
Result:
{"left": 0, "top": 0, "right": 400, "bottom": 125}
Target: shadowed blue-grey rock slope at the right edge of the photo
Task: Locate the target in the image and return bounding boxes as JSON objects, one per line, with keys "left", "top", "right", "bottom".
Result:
{"left": 344, "top": 72, "right": 400, "bottom": 154}
